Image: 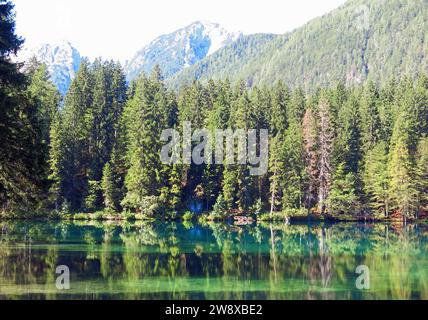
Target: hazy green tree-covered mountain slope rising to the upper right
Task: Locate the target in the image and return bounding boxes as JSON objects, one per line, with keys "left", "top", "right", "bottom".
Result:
{"left": 168, "top": 0, "right": 428, "bottom": 90}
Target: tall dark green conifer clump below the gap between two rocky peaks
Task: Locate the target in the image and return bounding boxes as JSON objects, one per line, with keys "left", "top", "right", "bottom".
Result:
{"left": 57, "top": 60, "right": 126, "bottom": 209}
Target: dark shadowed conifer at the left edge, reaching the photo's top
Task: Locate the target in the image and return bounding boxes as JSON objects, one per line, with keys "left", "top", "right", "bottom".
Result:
{"left": 0, "top": 0, "right": 46, "bottom": 210}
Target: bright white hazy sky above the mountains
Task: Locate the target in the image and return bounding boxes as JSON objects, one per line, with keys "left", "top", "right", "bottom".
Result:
{"left": 14, "top": 0, "right": 345, "bottom": 61}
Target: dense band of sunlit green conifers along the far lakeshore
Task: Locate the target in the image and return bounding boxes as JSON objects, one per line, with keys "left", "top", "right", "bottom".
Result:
{"left": 1, "top": 69, "right": 427, "bottom": 220}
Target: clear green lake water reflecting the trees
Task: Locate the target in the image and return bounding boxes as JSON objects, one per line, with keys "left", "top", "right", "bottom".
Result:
{"left": 0, "top": 222, "right": 428, "bottom": 300}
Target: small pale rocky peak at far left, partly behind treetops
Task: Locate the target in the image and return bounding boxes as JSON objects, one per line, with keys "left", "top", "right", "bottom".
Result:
{"left": 18, "top": 41, "right": 81, "bottom": 95}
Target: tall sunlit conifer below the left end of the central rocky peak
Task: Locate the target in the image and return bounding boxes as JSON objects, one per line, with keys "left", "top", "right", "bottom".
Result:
{"left": 122, "top": 70, "right": 167, "bottom": 211}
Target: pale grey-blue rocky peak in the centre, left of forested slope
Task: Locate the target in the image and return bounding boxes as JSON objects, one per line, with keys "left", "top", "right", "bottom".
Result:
{"left": 125, "top": 21, "right": 241, "bottom": 80}
